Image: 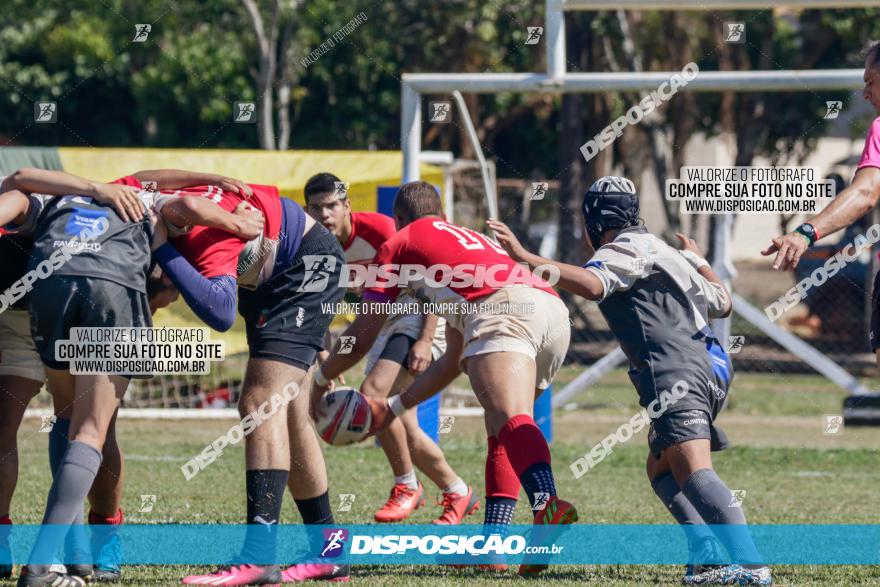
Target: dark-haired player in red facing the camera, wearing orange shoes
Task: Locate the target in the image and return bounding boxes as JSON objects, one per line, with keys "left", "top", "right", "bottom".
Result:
{"left": 304, "top": 173, "right": 479, "bottom": 524}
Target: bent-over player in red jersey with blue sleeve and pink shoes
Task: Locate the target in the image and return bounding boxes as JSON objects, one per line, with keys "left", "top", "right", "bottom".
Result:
{"left": 121, "top": 170, "right": 349, "bottom": 585}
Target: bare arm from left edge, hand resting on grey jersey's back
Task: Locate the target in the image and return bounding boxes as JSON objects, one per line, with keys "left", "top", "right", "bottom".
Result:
{"left": 0, "top": 167, "right": 144, "bottom": 222}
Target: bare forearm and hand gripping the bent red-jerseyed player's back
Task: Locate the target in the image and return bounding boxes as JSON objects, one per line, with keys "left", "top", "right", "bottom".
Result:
{"left": 162, "top": 197, "right": 265, "bottom": 240}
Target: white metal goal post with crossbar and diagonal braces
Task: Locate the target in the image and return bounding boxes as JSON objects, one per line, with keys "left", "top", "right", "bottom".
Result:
{"left": 400, "top": 0, "right": 876, "bottom": 407}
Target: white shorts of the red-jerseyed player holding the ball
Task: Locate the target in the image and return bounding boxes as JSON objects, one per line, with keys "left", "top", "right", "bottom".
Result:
{"left": 461, "top": 286, "right": 571, "bottom": 389}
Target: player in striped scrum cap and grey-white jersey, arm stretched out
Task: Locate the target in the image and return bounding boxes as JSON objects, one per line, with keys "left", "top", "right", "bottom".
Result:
{"left": 489, "top": 176, "right": 772, "bottom": 585}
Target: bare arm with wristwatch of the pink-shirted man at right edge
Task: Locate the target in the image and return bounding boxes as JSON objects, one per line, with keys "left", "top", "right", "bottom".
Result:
{"left": 761, "top": 167, "right": 880, "bottom": 271}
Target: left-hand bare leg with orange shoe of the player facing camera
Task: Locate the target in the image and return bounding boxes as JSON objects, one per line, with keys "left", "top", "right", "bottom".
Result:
{"left": 361, "top": 359, "right": 425, "bottom": 522}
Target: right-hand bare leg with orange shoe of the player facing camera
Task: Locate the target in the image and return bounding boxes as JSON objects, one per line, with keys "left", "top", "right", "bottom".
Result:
{"left": 390, "top": 370, "right": 480, "bottom": 524}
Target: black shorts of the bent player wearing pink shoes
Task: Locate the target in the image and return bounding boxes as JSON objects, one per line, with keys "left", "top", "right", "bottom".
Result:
{"left": 238, "top": 224, "right": 345, "bottom": 370}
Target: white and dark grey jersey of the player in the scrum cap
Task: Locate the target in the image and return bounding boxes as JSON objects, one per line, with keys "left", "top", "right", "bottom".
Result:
{"left": 584, "top": 226, "right": 733, "bottom": 411}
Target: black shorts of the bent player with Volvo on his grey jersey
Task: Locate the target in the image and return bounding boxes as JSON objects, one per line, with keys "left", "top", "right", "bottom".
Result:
{"left": 29, "top": 275, "right": 153, "bottom": 371}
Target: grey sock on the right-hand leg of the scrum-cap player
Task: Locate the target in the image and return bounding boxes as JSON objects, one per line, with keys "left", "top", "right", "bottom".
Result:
{"left": 681, "top": 469, "right": 763, "bottom": 567}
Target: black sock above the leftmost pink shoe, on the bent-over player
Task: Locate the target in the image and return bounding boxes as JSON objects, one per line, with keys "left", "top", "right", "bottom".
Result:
{"left": 243, "top": 469, "right": 288, "bottom": 564}
